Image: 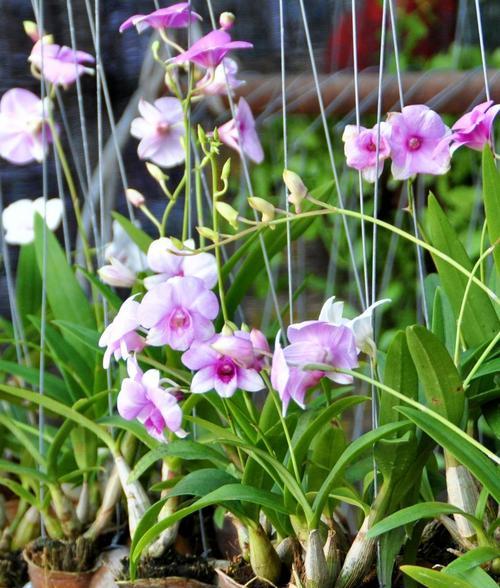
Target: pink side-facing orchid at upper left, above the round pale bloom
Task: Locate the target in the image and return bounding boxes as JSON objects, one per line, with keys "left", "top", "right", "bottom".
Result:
{"left": 28, "top": 39, "right": 95, "bottom": 86}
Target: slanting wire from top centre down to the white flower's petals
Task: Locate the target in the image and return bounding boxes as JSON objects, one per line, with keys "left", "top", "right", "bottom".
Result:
{"left": 299, "top": 0, "right": 366, "bottom": 307}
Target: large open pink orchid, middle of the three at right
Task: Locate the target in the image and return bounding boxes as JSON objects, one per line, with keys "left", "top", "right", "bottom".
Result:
{"left": 388, "top": 104, "right": 451, "bottom": 180}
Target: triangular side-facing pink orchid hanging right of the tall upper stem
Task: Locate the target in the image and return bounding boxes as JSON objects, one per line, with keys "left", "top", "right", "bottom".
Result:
{"left": 218, "top": 98, "right": 264, "bottom": 163}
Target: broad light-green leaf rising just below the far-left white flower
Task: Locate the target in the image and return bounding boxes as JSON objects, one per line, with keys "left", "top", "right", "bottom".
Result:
{"left": 35, "top": 214, "right": 95, "bottom": 328}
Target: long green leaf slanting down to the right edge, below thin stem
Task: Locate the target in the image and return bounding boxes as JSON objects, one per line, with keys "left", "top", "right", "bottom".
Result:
{"left": 398, "top": 407, "right": 500, "bottom": 502}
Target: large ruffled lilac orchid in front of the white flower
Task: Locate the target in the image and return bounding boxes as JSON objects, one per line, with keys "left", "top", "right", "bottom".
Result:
{"left": 271, "top": 321, "right": 358, "bottom": 412}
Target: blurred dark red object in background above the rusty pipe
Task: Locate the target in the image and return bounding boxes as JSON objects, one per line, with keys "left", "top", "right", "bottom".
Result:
{"left": 325, "top": 0, "right": 458, "bottom": 72}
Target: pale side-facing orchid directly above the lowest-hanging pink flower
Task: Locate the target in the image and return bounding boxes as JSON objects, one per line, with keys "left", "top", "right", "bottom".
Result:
{"left": 99, "top": 296, "right": 146, "bottom": 369}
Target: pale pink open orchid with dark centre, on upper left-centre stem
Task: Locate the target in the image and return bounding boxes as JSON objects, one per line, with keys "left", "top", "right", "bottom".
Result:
{"left": 130, "top": 97, "right": 185, "bottom": 167}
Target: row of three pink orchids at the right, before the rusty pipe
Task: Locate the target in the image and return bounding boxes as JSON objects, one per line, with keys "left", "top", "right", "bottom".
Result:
{"left": 342, "top": 101, "right": 500, "bottom": 182}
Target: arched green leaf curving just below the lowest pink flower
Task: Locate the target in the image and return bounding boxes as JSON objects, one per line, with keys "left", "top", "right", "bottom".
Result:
{"left": 129, "top": 439, "right": 229, "bottom": 482}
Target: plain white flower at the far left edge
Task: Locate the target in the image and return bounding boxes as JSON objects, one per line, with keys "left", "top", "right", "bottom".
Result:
{"left": 2, "top": 198, "right": 63, "bottom": 245}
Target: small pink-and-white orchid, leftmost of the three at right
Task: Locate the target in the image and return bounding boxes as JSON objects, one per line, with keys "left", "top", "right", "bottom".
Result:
{"left": 342, "top": 123, "right": 391, "bottom": 183}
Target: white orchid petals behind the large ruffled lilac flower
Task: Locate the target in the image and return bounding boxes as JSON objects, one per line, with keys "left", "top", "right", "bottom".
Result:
{"left": 319, "top": 296, "right": 391, "bottom": 357}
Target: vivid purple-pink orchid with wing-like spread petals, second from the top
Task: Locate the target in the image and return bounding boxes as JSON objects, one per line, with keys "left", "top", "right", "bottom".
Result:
{"left": 171, "top": 29, "right": 253, "bottom": 69}
